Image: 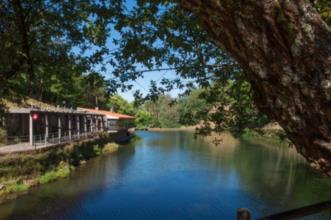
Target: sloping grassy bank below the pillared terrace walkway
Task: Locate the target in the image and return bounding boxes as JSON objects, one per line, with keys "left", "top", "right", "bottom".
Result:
{"left": 0, "top": 135, "right": 118, "bottom": 202}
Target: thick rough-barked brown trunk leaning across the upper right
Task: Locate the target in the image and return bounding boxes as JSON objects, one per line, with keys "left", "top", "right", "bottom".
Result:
{"left": 182, "top": 0, "right": 331, "bottom": 176}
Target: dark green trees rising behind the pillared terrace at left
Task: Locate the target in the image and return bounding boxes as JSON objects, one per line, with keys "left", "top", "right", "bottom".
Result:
{"left": 0, "top": 0, "right": 121, "bottom": 106}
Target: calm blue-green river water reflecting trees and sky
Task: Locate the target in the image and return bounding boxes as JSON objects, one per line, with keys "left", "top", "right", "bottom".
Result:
{"left": 0, "top": 131, "right": 331, "bottom": 220}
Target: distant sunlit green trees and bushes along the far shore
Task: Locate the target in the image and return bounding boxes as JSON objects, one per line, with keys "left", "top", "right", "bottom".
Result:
{"left": 136, "top": 79, "right": 269, "bottom": 136}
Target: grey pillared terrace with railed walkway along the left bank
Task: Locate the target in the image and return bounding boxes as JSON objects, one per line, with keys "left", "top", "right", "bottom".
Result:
{"left": 0, "top": 106, "right": 135, "bottom": 154}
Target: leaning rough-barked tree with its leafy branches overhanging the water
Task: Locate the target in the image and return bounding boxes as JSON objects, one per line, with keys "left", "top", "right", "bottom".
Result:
{"left": 106, "top": 0, "right": 331, "bottom": 175}
